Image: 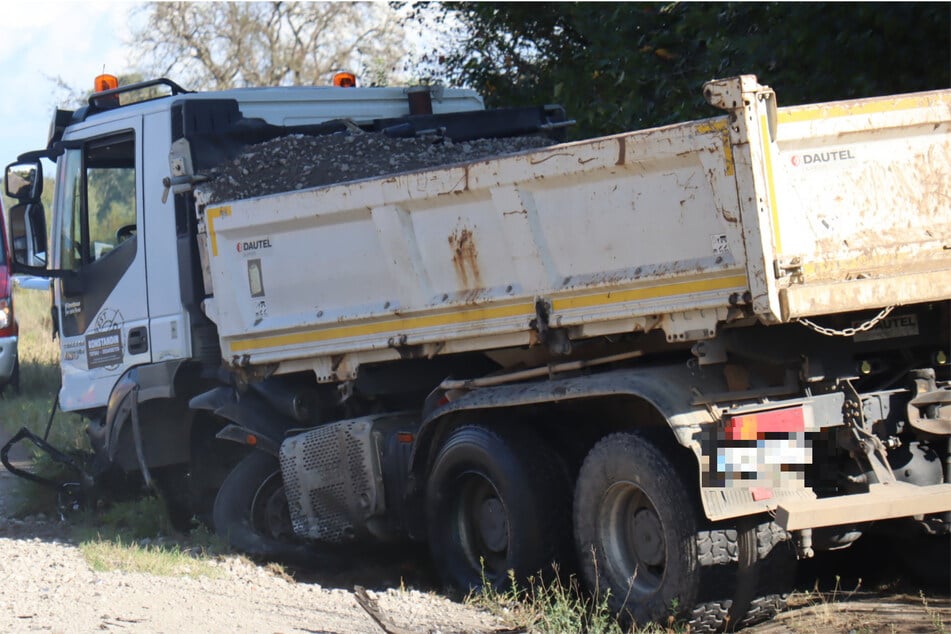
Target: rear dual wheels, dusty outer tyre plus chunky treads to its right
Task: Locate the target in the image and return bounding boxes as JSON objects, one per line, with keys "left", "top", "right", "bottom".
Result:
{"left": 574, "top": 433, "right": 794, "bottom": 632}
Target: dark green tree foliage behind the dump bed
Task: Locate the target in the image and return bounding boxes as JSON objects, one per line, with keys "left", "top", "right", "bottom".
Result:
{"left": 416, "top": 2, "right": 951, "bottom": 137}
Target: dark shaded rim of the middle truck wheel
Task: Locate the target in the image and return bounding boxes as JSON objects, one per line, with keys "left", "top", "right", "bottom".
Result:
{"left": 454, "top": 473, "right": 509, "bottom": 579}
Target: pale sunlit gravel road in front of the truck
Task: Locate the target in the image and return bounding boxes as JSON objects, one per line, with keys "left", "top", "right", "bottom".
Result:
{"left": 0, "top": 444, "right": 506, "bottom": 634}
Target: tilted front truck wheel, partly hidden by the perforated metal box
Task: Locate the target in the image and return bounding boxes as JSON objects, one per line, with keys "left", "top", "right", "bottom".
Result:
{"left": 214, "top": 451, "right": 308, "bottom": 562}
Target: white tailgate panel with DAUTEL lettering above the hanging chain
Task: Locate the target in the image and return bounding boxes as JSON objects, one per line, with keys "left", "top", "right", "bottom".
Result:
{"left": 766, "top": 91, "right": 951, "bottom": 321}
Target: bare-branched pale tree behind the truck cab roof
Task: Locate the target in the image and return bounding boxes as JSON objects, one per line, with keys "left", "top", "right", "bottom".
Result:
{"left": 134, "top": 2, "right": 403, "bottom": 89}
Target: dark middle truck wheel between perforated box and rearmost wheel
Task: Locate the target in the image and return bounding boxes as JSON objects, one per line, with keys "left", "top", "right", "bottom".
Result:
{"left": 426, "top": 425, "right": 570, "bottom": 592}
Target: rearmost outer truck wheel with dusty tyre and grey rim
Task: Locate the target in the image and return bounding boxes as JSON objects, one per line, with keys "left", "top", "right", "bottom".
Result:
{"left": 574, "top": 433, "right": 708, "bottom": 629}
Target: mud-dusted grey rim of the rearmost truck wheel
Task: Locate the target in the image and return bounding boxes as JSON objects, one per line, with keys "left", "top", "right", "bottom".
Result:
{"left": 598, "top": 481, "right": 667, "bottom": 597}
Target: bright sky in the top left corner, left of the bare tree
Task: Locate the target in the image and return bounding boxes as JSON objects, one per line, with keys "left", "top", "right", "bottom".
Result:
{"left": 0, "top": 0, "right": 139, "bottom": 167}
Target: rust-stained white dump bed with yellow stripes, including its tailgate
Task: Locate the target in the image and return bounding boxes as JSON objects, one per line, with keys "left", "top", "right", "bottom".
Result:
{"left": 199, "top": 76, "right": 951, "bottom": 380}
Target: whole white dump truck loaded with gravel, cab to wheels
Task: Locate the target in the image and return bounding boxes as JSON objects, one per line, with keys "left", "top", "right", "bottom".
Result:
{"left": 6, "top": 76, "right": 951, "bottom": 631}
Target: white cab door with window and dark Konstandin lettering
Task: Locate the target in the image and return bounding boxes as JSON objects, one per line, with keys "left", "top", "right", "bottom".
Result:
{"left": 52, "top": 117, "right": 152, "bottom": 411}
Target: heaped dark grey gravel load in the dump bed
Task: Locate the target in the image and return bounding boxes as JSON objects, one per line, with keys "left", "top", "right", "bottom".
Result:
{"left": 198, "top": 132, "right": 553, "bottom": 203}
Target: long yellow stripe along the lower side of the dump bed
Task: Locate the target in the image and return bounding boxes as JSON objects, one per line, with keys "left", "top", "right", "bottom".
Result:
{"left": 231, "top": 275, "right": 748, "bottom": 353}
